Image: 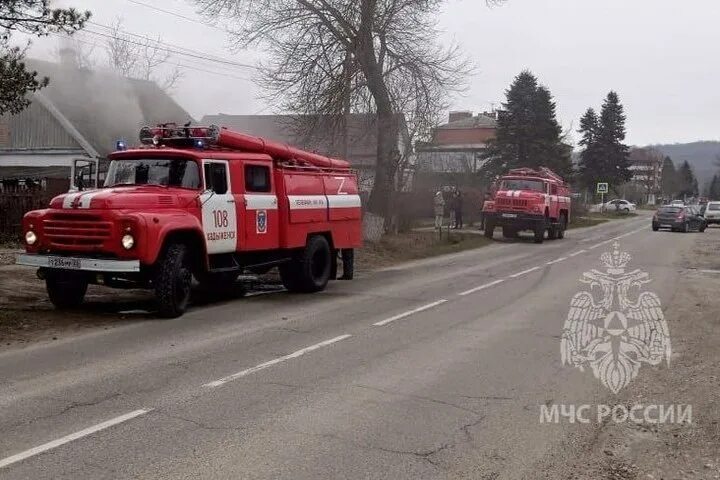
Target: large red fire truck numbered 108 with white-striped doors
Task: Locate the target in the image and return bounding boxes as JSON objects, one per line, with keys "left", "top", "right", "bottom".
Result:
{"left": 17, "top": 124, "right": 362, "bottom": 317}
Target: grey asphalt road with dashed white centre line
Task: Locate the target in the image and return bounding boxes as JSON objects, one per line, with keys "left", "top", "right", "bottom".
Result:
{"left": 0, "top": 215, "right": 696, "bottom": 480}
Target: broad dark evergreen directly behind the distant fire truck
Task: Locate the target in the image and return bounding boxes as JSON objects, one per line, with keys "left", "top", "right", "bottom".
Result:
{"left": 482, "top": 70, "right": 572, "bottom": 178}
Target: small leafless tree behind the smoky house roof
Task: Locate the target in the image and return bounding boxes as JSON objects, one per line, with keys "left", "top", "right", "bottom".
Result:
{"left": 106, "top": 18, "right": 183, "bottom": 91}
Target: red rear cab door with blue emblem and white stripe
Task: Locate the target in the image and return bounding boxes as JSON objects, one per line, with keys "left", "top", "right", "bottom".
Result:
{"left": 238, "top": 161, "right": 280, "bottom": 250}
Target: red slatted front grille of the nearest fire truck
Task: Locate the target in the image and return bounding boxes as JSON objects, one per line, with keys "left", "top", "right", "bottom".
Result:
{"left": 43, "top": 213, "right": 112, "bottom": 247}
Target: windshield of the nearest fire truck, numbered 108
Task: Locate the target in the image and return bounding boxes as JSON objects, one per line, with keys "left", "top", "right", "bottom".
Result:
{"left": 105, "top": 158, "right": 200, "bottom": 189}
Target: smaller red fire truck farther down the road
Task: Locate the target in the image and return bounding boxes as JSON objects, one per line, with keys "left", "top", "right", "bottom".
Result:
{"left": 483, "top": 167, "right": 570, "bottom": 243}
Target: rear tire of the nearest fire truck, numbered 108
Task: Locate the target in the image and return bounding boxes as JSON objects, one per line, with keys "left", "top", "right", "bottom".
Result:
{"left": 280, "top": 235, "right": 332, "bottom": 293}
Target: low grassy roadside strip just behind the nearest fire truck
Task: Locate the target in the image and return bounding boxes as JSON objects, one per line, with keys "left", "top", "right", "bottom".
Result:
{"left": 355, "top": 231, "right": 492, "bottom": 270}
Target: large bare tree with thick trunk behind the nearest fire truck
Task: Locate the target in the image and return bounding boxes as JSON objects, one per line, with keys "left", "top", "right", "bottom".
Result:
{"left": 195, "top": 0, "right": 499, "bottom": 216}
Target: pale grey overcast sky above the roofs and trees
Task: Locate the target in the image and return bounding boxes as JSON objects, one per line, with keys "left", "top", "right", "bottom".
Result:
{"left": 25, "top": 0, "right": 720, "bottom": 145}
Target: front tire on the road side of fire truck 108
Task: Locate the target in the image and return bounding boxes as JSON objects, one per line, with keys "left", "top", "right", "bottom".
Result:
{"left": 153, "top": 243, "right": 192, "bottom": 318}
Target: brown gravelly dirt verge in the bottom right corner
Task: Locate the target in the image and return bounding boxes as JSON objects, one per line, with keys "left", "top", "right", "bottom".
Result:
{"left": 536, "top": 229, "right": 720, "bottom": 480}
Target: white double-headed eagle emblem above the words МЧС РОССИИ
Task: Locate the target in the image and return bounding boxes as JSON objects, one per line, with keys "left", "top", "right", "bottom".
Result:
{"left": 560, "top": 242, "right": 671, "bottom": 393}
